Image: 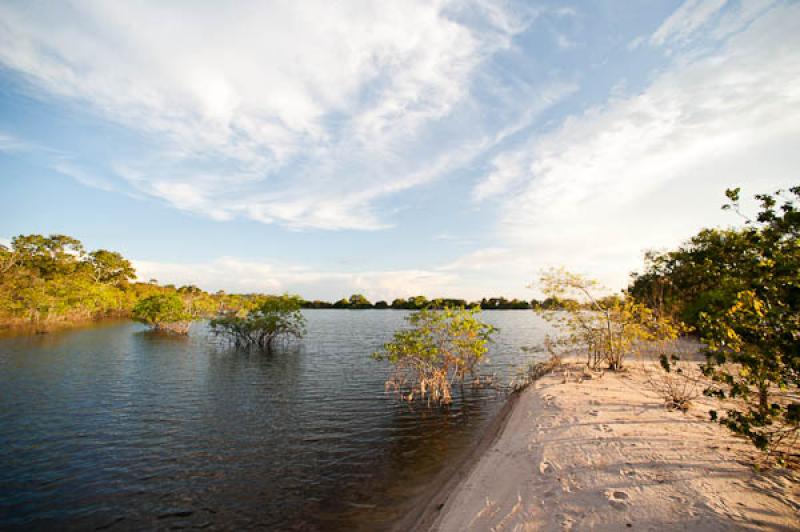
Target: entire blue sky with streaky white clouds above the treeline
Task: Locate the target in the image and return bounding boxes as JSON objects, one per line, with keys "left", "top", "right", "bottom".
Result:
{"left": 0, "top": 0, "right": 800, "bottom": 300}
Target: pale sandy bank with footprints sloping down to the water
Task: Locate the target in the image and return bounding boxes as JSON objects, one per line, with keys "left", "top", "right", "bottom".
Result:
{"left": 428, "top": 364, "right": 800, "bottom": 532}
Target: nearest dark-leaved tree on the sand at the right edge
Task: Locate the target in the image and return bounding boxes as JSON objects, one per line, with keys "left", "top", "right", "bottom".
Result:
{"left": 692, "top": 186, "right": 800, "bottom": 451}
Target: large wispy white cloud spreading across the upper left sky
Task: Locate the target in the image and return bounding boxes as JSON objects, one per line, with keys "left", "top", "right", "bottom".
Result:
{"left": 0, "top": 0, "right": 536, "bottom": 229}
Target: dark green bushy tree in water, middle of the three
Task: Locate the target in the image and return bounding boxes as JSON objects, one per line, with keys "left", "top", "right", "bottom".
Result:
{"left": 210, "top": 294, "right": 306, "bottom": 351}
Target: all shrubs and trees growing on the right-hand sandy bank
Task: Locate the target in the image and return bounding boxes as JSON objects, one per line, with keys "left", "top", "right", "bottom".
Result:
{"left": 538, "top": 187, "right": 800, "bottom": 459}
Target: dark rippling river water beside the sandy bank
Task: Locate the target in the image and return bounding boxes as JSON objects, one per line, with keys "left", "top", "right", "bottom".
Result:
{"left": 0, "top": 310, "right": 545, "bottom": 530}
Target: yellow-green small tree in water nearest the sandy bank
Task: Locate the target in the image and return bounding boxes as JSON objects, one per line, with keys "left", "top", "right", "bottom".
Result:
{"left": 373, "top": 308, "right": 496, "bottom": 404}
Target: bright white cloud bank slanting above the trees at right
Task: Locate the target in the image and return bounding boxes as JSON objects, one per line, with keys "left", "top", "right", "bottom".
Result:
{"left": 476, "top": 0, "right": 800, "bottom": 287}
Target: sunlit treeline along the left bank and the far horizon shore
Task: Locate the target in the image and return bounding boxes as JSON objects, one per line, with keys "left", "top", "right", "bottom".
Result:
{"left": 0, "top": 234, "right": 576, "bottom": 328}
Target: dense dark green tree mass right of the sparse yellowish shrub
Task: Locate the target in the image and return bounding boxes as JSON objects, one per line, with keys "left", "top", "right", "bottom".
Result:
{"left": 630, "top": 187, "right": 800, "bottom": 450}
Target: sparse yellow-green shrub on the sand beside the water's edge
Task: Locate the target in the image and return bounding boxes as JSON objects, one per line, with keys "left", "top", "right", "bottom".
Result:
{"left": 538, "top": 269, "right": 682, "bottom": 370}
